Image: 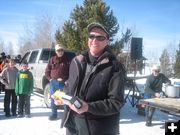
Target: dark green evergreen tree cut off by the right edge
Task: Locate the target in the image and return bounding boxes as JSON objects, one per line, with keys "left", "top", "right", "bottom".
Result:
{"left": 174, "top": 44, "right": 180, "bottom": 78}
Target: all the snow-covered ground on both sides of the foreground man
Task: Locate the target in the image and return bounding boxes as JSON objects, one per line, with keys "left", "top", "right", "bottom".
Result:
{"left": 0, "top": 86, "right": 180, "bottom": 135}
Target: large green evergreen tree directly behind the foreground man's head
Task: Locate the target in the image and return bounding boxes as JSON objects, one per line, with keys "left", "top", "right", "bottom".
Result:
{"left": 55, "top": 0, "right": 119, "bottom": 52}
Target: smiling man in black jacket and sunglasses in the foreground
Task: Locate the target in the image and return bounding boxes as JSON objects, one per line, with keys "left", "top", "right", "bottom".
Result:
{"left": 53, "top": 23, "right": 125, "bottom": 135}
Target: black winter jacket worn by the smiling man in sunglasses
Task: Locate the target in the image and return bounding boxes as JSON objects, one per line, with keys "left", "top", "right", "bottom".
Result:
{"left": 61, "top": 49, "right": 125, "bottom": 135}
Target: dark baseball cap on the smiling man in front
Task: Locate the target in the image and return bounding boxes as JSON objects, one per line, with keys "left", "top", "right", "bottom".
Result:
{"left": 87, "top": 22, "right": 109, "bottom": 39}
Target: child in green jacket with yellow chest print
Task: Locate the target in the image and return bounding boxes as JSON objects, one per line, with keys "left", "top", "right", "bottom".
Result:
{"left": 15, "top": 62, "right": 33, "bottom": 118}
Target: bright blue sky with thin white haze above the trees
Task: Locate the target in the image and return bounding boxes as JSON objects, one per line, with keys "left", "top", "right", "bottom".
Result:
{"left": 0, "top": 0, "right": 180, "bottom": 57}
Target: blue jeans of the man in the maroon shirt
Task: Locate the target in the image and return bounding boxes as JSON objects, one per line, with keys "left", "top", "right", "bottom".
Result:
{"left": 50, "top": 80, "right": 64, "bottom": 116}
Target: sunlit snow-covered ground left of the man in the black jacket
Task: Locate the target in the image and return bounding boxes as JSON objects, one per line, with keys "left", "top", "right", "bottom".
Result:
{"left": 0, "top": 94, "right": 65, "bottom": 135}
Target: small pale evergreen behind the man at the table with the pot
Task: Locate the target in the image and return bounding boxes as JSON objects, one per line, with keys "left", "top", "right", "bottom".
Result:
{"left": 159, "top": 49, "right": 172, "bottom": 77}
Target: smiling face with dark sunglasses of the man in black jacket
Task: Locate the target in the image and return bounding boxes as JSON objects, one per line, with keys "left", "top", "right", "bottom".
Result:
{"left": 88, "top": 27, "right": 109, "bottom": 56}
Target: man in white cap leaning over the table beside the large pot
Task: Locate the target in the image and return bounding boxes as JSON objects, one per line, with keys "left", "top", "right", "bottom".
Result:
{"left": 144, "top": 65, "right": 171, "bottom": 126}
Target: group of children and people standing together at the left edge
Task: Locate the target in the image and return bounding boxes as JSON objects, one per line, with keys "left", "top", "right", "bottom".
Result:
{"left": 0, "top": 53, "right": 33, "bottom": 118}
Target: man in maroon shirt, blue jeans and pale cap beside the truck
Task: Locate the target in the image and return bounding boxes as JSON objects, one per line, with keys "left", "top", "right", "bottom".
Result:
{"left": 45, "top": 44, "right": 70, "bottom": 120}
